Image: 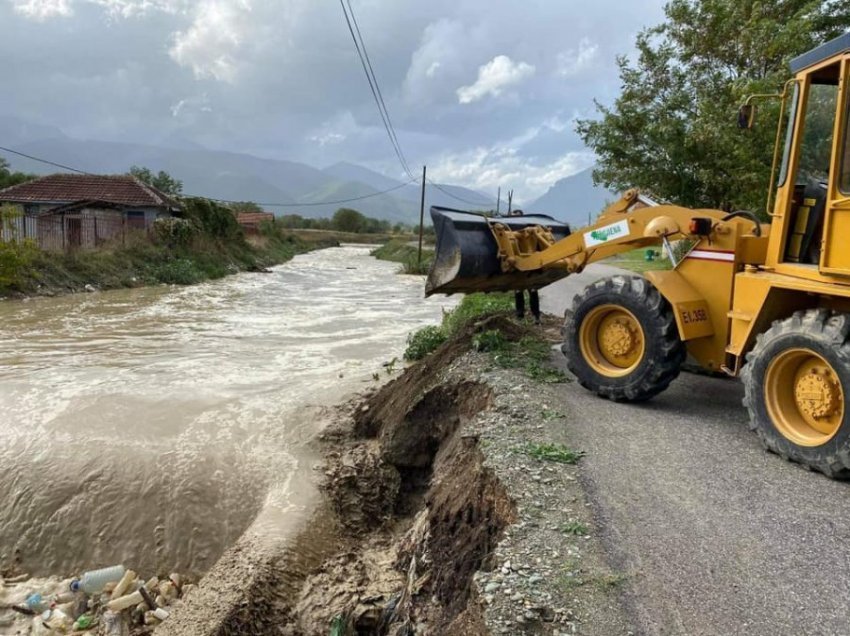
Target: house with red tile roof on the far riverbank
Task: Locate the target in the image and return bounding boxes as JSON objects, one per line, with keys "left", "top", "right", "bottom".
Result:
{"left": 0, "top": 174, "right": 180, "bottom": 250}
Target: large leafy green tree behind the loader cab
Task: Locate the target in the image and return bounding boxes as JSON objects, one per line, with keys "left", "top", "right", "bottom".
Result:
{"left": 577, "top": 0, "right": 850, "bottom": 211}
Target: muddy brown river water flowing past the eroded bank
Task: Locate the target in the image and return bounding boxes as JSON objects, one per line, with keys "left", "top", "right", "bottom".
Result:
{"left": 0, "top": 247, "right": 453, "bottom": 575}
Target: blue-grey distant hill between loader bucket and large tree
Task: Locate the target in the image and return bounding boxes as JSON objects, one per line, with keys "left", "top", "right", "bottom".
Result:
{"left": 525, "top": 168, "right": 619, "bottom": 227}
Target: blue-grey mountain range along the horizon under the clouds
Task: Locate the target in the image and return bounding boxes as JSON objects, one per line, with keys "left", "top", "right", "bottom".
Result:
{"left": 0, "top": 116, "right": 614, "bottom": 224}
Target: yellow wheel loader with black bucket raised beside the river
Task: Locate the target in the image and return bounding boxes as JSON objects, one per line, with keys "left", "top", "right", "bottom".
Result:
{"left": 426, "top": 33, "right": 850, "bottom": 478}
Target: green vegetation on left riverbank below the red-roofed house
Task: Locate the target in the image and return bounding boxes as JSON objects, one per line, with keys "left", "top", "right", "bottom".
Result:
{"left": 0, "top": 198, "right": 337, "bottom": 296}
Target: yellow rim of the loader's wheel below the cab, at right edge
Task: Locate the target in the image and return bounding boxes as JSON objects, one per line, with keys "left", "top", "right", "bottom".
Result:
{"left": 764, "top": 349, "right": 844, "bottom": 446}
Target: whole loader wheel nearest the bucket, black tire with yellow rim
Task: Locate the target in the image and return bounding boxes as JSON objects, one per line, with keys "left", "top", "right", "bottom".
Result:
{"left": 561, "top": 276, "right": 686, "bottom": 402}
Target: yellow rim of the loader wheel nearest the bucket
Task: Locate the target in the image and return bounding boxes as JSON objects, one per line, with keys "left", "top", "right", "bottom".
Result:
{"left": 579, "top": 305, "right": 646, "bottom": 378}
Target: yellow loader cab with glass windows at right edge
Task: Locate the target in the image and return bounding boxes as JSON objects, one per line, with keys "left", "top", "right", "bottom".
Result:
{"left": 766, "top": 33, "right": 850, "bottom": 284}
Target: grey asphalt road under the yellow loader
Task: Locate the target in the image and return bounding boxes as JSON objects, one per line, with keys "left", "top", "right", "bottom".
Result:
{"left": 541, "top": 266, "right": 850, "bottom": 636}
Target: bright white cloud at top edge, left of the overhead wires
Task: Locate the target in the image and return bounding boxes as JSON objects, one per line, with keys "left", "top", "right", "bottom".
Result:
{"left": 168, "top": 0, "right": 251, "bottom": 82}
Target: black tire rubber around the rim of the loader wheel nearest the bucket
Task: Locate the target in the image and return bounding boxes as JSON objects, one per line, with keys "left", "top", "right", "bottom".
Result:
{"left": 561, "top": 275, "right": 687, "bottom": 402}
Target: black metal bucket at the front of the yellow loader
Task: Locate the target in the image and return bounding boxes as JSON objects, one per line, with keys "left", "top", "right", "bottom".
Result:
{"left": 425, "top": 207, "right": 570, "bottom": 296}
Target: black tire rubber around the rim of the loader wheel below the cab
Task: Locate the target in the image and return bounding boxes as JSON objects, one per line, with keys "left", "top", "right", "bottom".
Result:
{"left": 741, "top": 309, "right": 850, "bottom": 479}
